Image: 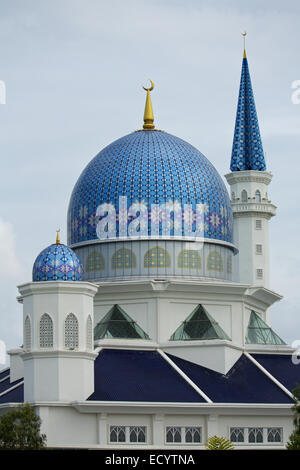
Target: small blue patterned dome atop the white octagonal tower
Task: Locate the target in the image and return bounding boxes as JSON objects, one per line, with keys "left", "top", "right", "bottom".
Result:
{"left": 32, "top": 243, "right": 83, "bottom": 282}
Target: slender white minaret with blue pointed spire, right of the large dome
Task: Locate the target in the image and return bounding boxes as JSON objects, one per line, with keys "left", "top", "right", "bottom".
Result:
{"left": 225, "top": 33, "right": 276, "bottom": 288}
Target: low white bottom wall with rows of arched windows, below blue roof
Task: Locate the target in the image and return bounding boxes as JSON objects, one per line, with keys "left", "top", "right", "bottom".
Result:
{"left": 37, "top": 403, "right": 293, "bottom": 449}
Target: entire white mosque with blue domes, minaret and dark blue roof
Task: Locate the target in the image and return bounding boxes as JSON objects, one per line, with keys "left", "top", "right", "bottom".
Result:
{"left": 0, "top": 42, "right": 300, "bottom": 449}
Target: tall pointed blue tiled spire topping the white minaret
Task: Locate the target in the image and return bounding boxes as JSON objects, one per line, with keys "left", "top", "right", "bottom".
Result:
{"left": 230, "top": 50, "right": 266, "bottom": 171}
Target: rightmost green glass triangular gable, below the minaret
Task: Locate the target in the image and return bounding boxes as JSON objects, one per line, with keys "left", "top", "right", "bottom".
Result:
{"left": 246, "top": 310, "right": 286, "bottom": 344}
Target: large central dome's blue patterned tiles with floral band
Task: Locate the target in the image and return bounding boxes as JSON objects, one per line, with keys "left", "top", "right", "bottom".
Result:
{"left": 68, "top": 130, "right": 232, "bottom": 245}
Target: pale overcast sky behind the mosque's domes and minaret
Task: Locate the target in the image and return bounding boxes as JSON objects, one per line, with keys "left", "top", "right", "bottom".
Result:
{"left": 0, "top": 0, "right": 300, "bottom": 360}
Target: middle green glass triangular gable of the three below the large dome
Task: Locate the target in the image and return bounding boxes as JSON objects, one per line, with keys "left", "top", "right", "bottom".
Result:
{"left": 170, "top": 304, "right": 230, "bottom": 341}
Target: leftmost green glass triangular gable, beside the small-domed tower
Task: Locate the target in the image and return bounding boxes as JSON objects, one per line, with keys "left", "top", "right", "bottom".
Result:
{"left": 94, "top": 304, "right": 149, "bottom": 340}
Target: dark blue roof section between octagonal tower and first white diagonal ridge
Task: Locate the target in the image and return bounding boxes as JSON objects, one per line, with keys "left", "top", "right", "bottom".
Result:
{"left": 88, "top": 349, "right": 204, "bottom": 402}
